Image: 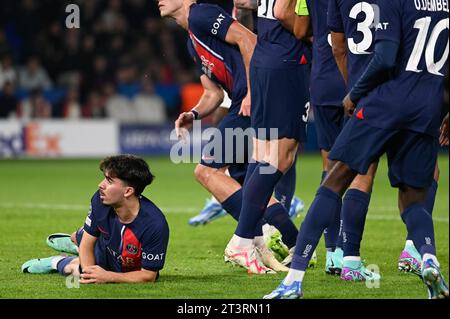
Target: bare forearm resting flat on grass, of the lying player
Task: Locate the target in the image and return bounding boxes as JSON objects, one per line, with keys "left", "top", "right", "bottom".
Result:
{"left": 80, "top": 266, "right": 157, "bottom": 284}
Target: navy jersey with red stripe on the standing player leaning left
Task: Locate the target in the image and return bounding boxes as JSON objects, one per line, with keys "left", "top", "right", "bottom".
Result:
{"left": 188, "top": 4, "right": 247, "bottom": 112}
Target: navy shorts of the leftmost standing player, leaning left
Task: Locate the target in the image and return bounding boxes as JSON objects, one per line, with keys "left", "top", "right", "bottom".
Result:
{"left": 200, "top": 110, "right": 253, "bottom": 185}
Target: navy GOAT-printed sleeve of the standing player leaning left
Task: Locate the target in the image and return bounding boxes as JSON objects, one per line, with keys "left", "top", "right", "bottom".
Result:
{"left": 189, "top": 4, "right": 235, "bottom": 41}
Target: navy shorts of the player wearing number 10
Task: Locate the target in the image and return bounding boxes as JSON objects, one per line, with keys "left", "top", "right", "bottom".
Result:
{"left": 328, "top": 116, "right": 438, "bottom": 188}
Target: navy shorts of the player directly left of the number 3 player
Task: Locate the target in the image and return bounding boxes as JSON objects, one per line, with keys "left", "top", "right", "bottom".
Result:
{"left": 314, "top": 105, "right": 348, "bottom": 152}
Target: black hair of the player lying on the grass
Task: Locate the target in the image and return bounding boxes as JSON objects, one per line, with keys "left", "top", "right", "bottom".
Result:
{"left": 100, "top": 155, "right": 155, "bottom": 196}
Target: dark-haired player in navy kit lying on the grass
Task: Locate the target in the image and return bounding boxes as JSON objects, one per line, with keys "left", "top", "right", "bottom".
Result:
{"left": 22, "top": 155, "right": 169, "bottom": 284}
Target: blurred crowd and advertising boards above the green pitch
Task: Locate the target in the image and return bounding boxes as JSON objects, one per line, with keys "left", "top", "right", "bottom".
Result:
{"left": 0, "top": 0, "right": 448, "bottom": 158}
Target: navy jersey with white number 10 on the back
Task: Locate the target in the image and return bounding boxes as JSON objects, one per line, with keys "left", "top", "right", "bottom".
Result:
{"left": 358, "top": 0, "right": 449, "bottom": 135}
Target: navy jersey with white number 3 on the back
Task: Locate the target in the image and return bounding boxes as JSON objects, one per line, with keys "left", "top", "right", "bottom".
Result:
{"left": 328, "top": 0, "right": 382, "bottom": 89}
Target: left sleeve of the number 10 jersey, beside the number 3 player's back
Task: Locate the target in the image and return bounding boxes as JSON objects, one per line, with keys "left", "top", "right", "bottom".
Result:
{"left": 375, "top": 0, "right": 402, "bottom": 43}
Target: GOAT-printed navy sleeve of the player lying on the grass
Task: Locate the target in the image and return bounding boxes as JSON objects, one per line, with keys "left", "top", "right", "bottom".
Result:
{"left": 142, "top": 221, "right": 169, "bottom": 271}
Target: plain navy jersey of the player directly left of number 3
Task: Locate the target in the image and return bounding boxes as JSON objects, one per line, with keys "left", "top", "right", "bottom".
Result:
{"left": 306, "top": 0, "right": 346, "bottom": 105}
